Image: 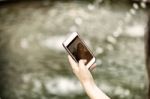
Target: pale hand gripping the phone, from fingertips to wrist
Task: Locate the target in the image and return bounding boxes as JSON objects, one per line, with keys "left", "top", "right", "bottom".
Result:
{"left": 68, "top": 55, "right": 96, "bottom": 85}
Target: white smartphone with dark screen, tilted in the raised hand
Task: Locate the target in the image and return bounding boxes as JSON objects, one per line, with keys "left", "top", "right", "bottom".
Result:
{"left": 62, "top": 32, "right": 95, "bottom": 69}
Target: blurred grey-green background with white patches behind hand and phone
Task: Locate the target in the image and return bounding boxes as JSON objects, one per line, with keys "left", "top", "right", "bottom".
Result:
{"left": 0, "top": 0, "right": 150, "bottom": 99}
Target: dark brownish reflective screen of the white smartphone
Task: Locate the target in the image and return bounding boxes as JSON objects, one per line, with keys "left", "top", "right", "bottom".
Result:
{"left": 67, "top": 36, "right": 93, "bottom": 64}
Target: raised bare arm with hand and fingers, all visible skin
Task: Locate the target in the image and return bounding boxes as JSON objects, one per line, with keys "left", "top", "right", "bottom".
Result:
{"left": 68, "top": 55, "right": 110, "bottom": 99}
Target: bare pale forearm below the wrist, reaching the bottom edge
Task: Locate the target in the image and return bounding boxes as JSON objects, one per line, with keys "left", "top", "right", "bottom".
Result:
{"left": 82, "top": 83, "right": 110, "bottom": 99}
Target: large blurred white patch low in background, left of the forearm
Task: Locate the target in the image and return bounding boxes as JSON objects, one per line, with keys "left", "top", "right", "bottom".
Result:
{"left": 45, "top": 78, "right": 82, "bottom": 95}
